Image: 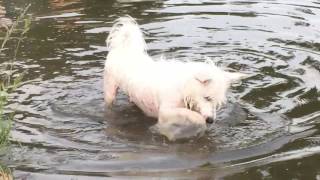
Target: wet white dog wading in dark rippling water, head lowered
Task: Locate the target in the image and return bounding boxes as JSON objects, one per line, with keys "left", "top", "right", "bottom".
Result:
{"left": 104, "top": 16, "right": 245, "bottom": 140}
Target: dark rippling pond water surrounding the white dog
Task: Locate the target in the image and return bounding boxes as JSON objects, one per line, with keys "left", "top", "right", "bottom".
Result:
{"left": 0, "top": 0, "right": 320, "bottom": 180}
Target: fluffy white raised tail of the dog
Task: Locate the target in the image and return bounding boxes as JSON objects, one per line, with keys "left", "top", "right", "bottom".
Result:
{"left": 106, "top": 16, "right": 147, "bottom": 52}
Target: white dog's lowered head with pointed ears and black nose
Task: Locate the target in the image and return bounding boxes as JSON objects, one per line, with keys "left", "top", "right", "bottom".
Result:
{"left": 184, "top": 66, "right": 247, "bottom": 123}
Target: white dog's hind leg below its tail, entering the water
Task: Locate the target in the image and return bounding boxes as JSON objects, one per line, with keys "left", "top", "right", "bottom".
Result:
{"left": 103, "top": 70, "right": 118, "bottom": 107}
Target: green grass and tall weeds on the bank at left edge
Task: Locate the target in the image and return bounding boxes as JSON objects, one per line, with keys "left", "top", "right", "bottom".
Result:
{"left": 0, "top": 5, "right": 31, "bottom": 150}
